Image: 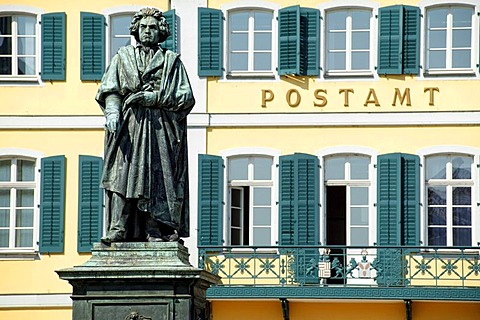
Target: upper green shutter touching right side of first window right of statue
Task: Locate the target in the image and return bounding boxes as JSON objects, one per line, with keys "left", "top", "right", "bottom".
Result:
{"left": 278, "top": 6, "right": 300, "bottom": 75}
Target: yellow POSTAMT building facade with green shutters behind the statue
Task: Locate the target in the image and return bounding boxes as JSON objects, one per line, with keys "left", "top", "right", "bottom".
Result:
{"left": 0, "top": 0, "right": 480, "bottom": 319}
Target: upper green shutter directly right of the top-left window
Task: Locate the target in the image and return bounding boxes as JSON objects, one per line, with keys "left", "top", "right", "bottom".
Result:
{"left": 41, "top": 12, "right": 67, "bottom": 81}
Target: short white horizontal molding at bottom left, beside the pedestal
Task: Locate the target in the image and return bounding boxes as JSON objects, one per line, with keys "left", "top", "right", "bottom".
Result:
{"left": 0, "top": 294, "right": 72, "bottom": 309}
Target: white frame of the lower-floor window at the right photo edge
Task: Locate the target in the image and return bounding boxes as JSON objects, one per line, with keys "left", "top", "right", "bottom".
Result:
{"left": 417, "top": 146, "right": 480, "bottom": 246}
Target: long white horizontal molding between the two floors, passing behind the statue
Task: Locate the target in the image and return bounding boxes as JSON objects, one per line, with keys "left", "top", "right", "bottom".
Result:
{"left": 0, "top": 111, "right": 480, "bottom": 130}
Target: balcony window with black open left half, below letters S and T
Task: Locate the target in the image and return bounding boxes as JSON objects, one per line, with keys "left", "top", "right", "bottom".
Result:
{"left": 325, "top": 156, "right": 372, "bottom": 245}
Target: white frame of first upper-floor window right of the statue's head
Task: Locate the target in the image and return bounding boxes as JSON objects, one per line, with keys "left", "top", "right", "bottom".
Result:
{"left": 220, "top": 0, "right": 281, "bottom": 79}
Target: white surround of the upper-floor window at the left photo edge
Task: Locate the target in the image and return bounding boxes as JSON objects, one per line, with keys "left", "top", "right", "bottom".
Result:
{"left": 0, "top": 5, "right": 44, "bottom": 84}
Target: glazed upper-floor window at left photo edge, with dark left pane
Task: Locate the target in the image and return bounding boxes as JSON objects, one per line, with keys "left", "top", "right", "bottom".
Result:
{"left": 0, "top": 15, "right": 38, "bottom": 77}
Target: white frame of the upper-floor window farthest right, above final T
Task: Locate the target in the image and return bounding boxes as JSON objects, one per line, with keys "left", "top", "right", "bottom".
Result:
{"left": 420, "top": 1, "right": 479, "bottom": 75}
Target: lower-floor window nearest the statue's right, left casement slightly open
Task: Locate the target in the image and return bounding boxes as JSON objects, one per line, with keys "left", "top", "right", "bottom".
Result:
{"left": 227, "top": 156, "right": 273, "bottom": 246}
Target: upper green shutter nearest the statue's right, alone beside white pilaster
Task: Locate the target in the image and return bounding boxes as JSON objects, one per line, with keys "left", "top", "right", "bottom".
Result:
{"left": 198, "top": 8, "right": 223, "bottom": 77}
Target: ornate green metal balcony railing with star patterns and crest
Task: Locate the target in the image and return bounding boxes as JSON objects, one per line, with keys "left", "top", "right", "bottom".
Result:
{"left": 199, "top": 246, "right": 480, "bottom": 291}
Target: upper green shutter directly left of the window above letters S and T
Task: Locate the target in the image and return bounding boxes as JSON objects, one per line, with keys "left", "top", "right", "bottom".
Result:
{"left": 300, "top": 8, "right": 320, "bottom": 76}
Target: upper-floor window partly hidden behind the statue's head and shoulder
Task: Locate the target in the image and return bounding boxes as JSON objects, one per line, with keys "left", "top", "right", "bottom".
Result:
{"left": 108, "top": 13, "right": 135, "bottom": 59}
